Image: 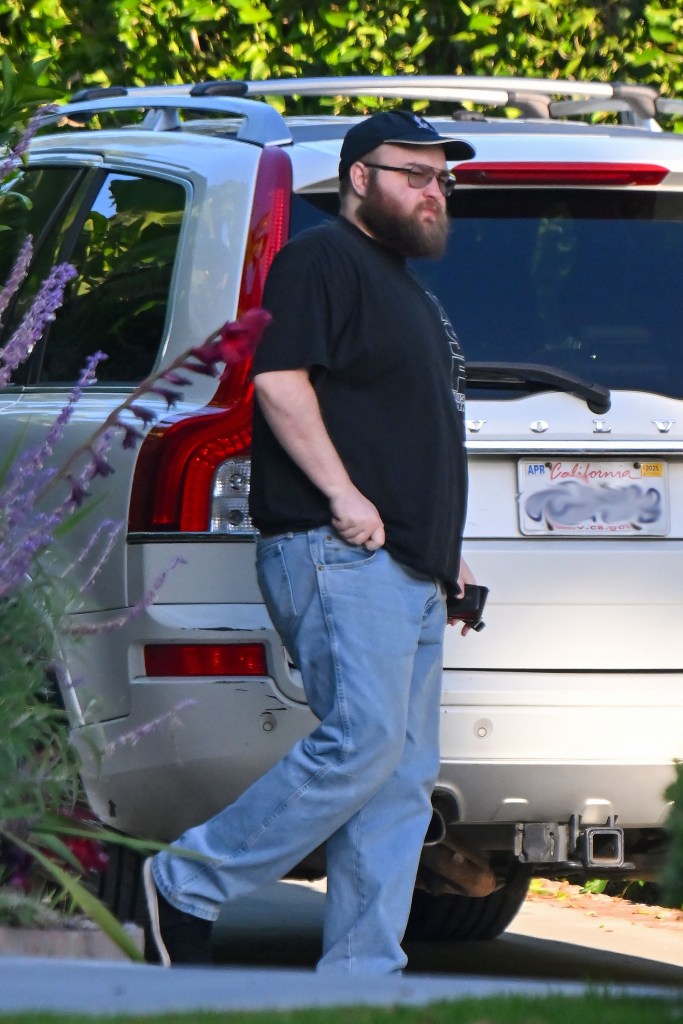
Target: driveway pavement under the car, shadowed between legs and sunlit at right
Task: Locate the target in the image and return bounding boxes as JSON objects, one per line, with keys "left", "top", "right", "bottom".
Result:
{"left": 216, "top": 883, "right": 683, "bottom": 988}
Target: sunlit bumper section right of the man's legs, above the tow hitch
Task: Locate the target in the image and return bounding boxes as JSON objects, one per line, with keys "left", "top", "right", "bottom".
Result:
{"left": 440, "top": 671, "right": 683, "bottom": 827}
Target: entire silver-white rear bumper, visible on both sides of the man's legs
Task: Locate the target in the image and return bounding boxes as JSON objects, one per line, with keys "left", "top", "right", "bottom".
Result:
{"left": 67, "top": 601, "right": 683, "bottom": 840}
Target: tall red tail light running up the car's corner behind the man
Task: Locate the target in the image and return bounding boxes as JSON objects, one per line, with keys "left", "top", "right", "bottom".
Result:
{"left": 129, "top": 146, "right": 292, "bottom": 531}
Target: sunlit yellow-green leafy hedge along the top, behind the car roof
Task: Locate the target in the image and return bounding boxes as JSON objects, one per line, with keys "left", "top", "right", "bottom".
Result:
{"left": 0, "top": 0, "right": 683, "bottom": 105}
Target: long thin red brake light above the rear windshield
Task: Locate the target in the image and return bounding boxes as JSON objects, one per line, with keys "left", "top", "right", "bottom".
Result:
{"left": 453, "top": 161, "right": 669, "bottom": 185}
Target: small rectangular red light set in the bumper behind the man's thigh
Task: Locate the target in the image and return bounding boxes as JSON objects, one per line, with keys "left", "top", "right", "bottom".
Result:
{"left": 144, "top": 643, "right": 267, "bottom": 677}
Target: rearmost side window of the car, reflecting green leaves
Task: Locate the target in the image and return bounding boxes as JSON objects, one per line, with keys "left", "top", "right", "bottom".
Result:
{"left": 32, "top": 173, "right": 185, "bottom": 383}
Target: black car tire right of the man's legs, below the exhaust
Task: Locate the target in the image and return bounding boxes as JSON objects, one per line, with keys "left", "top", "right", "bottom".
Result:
{"left": 405, "top": 864, "right": 530, "bottom": 942}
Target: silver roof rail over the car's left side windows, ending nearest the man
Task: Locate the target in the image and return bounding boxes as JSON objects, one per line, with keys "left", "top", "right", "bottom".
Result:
{"left": 41, "top": 82, "right": 292, "bottom": 145}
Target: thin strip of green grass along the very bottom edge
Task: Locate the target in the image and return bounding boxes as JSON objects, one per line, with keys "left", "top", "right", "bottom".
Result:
{"left": 0, "top": 990, "right": 683, "bottom": 1024}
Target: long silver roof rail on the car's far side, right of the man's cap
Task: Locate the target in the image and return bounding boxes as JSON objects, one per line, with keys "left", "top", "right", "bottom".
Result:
{"left": 247, "top": 75, "right": 657, "bottom": 128}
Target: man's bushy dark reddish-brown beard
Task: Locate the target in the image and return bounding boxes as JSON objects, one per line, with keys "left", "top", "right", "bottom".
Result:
{"left": 356, "top": 177, "right": 449, "bottom": 259}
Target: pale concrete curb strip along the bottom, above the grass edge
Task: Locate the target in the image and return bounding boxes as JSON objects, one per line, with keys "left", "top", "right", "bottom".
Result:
{"left": 0, "top": 957, "right": 682, "bottom": 1019}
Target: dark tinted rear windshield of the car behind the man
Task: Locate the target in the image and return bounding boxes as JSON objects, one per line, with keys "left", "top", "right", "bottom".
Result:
{"left": 293, "top": 188, "right": 683, "bottom": 399}
